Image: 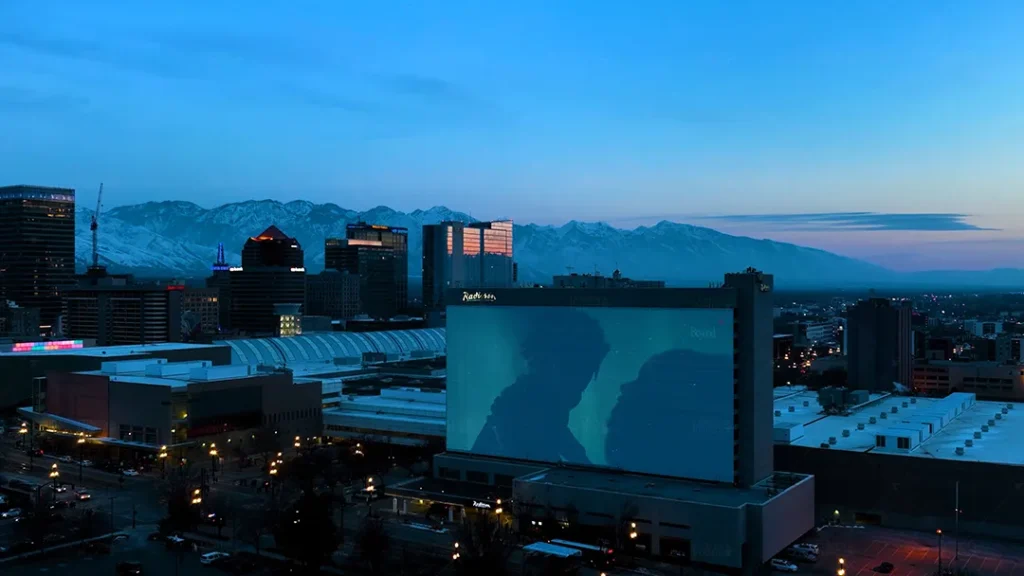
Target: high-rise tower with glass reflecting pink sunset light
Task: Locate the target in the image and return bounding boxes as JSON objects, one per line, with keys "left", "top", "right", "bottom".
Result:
{"left": 423, "top": 220, "right": 516, "bottom": 313}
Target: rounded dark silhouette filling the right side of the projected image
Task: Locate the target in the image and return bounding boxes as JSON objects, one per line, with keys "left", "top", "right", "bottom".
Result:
{"left": 604, "top": 349, "right": 733, "bottom": 476}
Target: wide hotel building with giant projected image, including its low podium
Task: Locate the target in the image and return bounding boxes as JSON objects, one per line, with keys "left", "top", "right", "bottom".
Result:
{"left": 385, "top": 270, "right": 815, "bottom": 574}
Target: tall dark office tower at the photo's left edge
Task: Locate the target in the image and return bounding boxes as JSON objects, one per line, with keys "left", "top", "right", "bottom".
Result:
{"left": 0, "top": 186, "right": 75, "bottom": 332}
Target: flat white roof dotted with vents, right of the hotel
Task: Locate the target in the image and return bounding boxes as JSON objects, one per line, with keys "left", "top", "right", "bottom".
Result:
{"left": 775, "top": 387, "right": 1024, "bottom": 465}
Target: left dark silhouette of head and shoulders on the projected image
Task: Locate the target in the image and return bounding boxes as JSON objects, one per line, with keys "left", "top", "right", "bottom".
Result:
{"left": 473, "top": 307, "right": 609, "bottom": 463}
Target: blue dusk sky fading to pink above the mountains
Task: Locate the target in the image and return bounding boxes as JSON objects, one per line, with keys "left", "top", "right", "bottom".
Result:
{"left": 0, "top": 0, "right": 1024, "bottom": 270}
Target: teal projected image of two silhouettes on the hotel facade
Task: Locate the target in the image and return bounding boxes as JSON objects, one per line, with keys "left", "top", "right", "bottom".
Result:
{"left": 446, "top": 305, "right": 733, "bottom": 482}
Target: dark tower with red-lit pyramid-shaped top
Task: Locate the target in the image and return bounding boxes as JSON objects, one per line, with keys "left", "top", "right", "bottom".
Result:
{"left": 229, "top": 225, "right": 306, "bottom": 334}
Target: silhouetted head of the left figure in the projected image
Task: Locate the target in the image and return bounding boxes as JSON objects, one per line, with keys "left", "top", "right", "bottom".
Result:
{"left": 520, "top": 307, "right": 609, "bottom": 408}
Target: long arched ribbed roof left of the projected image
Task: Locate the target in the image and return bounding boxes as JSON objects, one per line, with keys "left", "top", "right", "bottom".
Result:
{"left": 216, "top": 328, "right": 445, "bottom": 366}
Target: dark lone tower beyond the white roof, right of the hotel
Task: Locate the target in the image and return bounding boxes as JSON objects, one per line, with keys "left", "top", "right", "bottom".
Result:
{"left": 847, "top": 298, "right": 913, "bottom": 392}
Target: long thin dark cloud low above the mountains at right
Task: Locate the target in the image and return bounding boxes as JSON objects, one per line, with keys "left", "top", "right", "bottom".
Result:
{"left": 697, "top": 212, "right": 996, "bottom": 232}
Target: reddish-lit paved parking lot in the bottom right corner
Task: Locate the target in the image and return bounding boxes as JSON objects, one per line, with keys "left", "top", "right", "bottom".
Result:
{"left": 801, "top": 527, "right": 1024, "bottom": 576}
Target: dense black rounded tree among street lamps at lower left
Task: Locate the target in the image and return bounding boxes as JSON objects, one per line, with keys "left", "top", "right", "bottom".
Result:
{"left": 274, "top": 490, "right": 339, "bottom": 569}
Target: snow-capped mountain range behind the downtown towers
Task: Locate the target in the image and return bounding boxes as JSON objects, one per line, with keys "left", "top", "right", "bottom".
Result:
{"left": 76, "top": 200, "right": 892, "bottom": 285}
